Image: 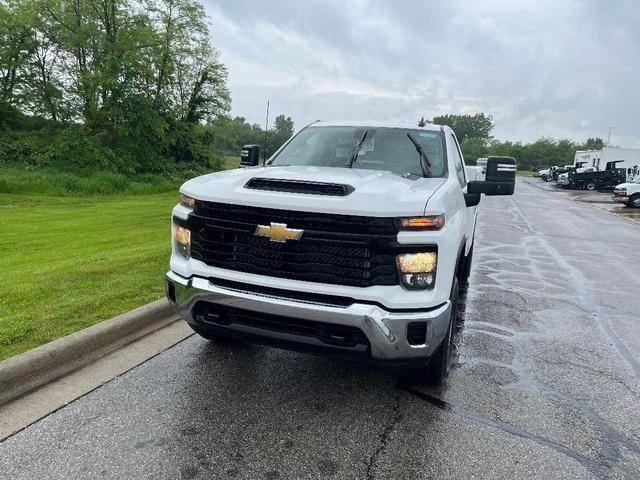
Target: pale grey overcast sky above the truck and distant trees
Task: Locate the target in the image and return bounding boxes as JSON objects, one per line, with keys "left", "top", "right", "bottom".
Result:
{"left": 204, "top": 0, "right": 640, "bottom": 147}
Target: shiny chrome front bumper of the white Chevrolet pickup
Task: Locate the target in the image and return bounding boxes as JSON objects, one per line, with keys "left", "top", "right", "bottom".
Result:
{"left": 166, "top": 271, "right": 451, "bottom": 363}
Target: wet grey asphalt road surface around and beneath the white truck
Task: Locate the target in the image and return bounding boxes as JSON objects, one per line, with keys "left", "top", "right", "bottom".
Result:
{"left": 0, "top": 182, "right": 640, "bottom": 480}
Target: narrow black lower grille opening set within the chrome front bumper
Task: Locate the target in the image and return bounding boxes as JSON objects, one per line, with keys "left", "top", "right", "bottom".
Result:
{"left": 193, "top": 302, "right": 369, "bottom": 347}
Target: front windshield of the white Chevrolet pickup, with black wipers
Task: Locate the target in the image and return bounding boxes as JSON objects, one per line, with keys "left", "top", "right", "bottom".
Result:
{"left": 269, "top": 126, "right": 446, "bottom": 177}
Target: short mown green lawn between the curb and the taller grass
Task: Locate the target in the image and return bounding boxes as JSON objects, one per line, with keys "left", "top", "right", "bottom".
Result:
{"left": 0, "top": 188, "right": 177, "bottom": 360}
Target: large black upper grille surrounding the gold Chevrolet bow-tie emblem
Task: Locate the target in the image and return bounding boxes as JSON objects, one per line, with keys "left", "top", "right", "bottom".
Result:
{"left": 188, "top": 201, "right": 398, "bottom": 287}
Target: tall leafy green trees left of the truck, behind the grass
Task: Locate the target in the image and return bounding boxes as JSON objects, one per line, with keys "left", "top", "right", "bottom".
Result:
{"left": 0, "top": 0, "right": 293, "bottom": 173}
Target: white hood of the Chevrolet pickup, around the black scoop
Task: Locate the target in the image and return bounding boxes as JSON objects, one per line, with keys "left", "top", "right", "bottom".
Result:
{"left": 180, "top": 166, "right": 446, "bottom": 217}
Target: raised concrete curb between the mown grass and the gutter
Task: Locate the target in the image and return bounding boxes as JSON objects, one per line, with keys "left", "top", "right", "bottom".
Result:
{"left": 0, "top": 299, "right": 178, "bottom": 405}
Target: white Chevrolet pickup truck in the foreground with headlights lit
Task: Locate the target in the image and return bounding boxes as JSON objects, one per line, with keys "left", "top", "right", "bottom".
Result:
{"left": 166, "top": 122, "right": 516, "bottom": 383}
